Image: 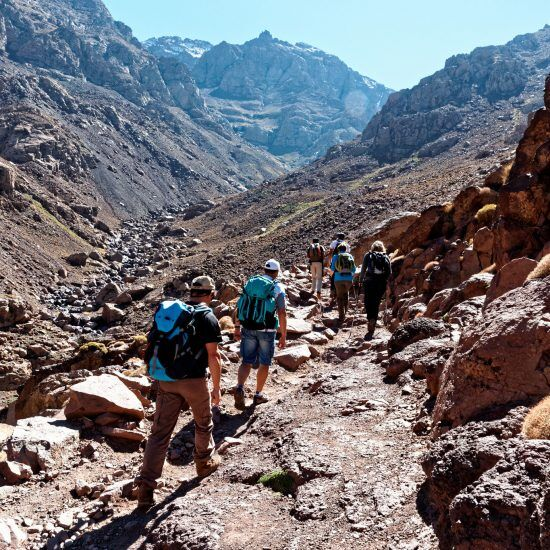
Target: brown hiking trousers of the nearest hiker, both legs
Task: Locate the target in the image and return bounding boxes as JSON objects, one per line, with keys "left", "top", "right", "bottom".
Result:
{"left": 137, "top": 378, "right": 214, "bottom": 488}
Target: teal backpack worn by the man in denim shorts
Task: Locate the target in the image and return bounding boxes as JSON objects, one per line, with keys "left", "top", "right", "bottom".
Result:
{"left": 237, "top": 275, "right": 279, "bottom": 330}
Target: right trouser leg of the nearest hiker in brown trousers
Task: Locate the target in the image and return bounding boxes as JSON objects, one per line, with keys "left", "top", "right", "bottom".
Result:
{"left": 181, "top": 378, "right": 214, "bottom": 460}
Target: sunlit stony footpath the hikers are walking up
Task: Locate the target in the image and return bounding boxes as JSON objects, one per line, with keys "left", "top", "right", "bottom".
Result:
{"left": 63, "top": 314, "right": 437, "bottom": 550}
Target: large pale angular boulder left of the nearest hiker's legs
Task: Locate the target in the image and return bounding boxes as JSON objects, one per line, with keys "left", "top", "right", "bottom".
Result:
{"left": 65, "top": 374, "right": 144, "bottom": 420}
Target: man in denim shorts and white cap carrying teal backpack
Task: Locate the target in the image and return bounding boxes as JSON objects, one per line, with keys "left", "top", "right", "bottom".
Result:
{"left": 234, "top": 259, "right": 286, "bottom": 410}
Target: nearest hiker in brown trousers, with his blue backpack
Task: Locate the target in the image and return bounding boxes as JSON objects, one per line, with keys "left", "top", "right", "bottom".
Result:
{"left": 136, "top": 276, "right": 222, "bottom": 508}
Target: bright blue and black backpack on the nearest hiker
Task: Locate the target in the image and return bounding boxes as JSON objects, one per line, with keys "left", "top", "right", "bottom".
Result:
{"left": 145, "top": 300, "right": 212, "bottom": 382}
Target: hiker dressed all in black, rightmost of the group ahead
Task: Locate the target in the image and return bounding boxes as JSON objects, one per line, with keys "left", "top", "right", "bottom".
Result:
{"left": 360, "top": 241, "right": 391, "bottom": 339}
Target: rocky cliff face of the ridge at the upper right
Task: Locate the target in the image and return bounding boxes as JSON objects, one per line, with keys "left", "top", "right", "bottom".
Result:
{"left": 362, "top": 25, "right": 550, "bottom": 163}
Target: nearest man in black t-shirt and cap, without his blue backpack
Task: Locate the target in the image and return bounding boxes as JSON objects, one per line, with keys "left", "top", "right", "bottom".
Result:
{"left": 136, "top": 276, "right": 222, "bottom": 508}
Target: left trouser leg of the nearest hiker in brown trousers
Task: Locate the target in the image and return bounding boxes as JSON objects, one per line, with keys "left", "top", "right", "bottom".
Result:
{"left": 137, "top": 382, "right": 183, "bottom": 488}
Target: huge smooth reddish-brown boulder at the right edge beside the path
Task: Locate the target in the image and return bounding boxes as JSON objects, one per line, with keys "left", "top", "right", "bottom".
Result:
{"left": 434, "top": 277, "right": 550, "bottom": 433}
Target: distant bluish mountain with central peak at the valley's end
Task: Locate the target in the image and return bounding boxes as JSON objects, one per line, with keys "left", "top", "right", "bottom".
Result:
{"left": 145, "top": 31, "right": 391, "bottom": 165}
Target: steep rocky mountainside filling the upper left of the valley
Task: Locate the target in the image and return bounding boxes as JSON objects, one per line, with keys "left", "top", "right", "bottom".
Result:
{"left": 0, "top": 0, "right": 283, "bottom": 306}
